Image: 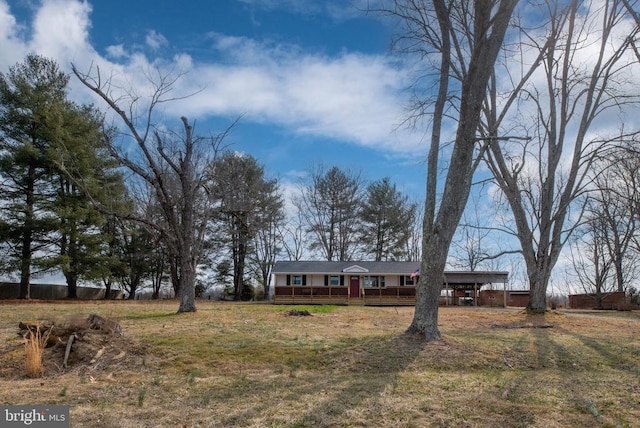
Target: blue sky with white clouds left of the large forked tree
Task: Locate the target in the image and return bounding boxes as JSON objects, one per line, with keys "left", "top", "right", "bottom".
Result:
{"left": 0, "top": 0, "right": 426, "bottom": 200}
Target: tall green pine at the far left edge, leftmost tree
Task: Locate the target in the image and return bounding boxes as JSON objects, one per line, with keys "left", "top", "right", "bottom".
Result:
{"left": 0, "top": 55, "right": 69, "bottom": 299}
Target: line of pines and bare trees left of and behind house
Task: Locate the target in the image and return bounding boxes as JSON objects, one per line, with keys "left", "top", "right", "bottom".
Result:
{"left": 0, "top": 55, "right": 417, "bottom": 312}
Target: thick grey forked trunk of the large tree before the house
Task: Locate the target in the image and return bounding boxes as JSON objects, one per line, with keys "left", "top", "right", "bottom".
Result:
{"left": 407, "top": 0, "right": 518, "bottom": 340}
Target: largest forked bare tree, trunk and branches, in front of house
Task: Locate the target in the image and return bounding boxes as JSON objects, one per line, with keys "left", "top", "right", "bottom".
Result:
{"left": 381, "top": 0, "right": 518, "bottom": 340}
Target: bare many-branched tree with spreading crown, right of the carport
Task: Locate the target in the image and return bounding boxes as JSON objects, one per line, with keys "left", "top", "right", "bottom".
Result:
{"left": 486, "top": 1, "right": 638, "bottom": 312}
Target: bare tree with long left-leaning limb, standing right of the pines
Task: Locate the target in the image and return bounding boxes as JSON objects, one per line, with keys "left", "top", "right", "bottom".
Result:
{"left": 72, "top": 65, "right": 233, "bottom": 312}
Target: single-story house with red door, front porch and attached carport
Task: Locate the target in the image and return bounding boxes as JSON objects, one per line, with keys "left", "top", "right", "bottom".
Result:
{"left": 272, "top": 261, "right": 509, "bottom": 305}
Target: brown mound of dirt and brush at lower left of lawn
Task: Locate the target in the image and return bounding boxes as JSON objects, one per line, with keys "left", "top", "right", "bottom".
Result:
{"left": 0, "top": 314, "right": 147, "bottom": 379}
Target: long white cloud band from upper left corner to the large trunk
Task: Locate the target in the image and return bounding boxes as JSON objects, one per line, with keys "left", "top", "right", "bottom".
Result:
{"left": 0, "top": 0, "right": 419, "bottom": 157}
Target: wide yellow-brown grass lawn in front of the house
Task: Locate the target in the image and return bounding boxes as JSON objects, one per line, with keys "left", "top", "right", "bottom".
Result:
{"left": 0, "top": 301, "right": 640, "bottom": 428}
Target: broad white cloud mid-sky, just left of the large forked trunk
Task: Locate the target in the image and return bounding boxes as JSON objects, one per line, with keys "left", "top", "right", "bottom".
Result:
{"left": 165, "top": 35, "right": 419, "bottom": 152}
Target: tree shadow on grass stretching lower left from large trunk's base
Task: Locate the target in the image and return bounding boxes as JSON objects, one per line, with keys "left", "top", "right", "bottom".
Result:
{"left": 207, "top": 335, "right": 426, "bottom": 427}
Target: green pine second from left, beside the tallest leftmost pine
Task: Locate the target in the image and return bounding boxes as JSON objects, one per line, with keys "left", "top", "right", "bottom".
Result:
{"left": 45, "top": 104, "right": 129, "bottom": 298}
